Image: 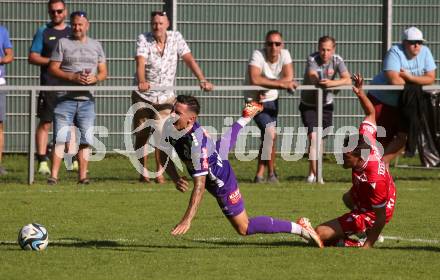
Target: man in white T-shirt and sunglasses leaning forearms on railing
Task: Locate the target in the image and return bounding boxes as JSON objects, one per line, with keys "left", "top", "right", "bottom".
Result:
{"left": 245, "top": 30, "right": 297, "bottom": 183}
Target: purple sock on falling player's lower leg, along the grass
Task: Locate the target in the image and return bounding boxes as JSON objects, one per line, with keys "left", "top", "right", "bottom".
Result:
{"left": 246, "top": 216, "right": 292, "bottom": 235}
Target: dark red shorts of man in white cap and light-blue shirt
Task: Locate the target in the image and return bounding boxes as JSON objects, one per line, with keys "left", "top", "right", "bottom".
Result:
{"left": 368, "top": 95, "right": 408, "bottom": 147}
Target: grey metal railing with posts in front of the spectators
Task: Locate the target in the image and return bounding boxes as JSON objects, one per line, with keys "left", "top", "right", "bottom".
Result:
{"left": 1, "top": 85, "right": 440, "bottom": 184}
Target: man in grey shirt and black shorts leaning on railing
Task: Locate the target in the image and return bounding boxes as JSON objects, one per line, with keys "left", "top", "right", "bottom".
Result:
{"left": 299, "top": 36, "right": 351, "bottom": 183}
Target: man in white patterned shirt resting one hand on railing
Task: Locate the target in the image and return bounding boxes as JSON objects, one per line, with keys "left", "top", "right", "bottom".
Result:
{"left": 132, "top": 11, "right": 213, "bottom": 183}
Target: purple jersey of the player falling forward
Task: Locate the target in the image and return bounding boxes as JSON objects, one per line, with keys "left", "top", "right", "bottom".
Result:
{"left": 169, "top": 122, "right": 242, "bottom": 198}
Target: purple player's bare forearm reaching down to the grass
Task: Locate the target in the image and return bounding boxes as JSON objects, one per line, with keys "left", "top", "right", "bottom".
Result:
{"left": 171, "top": 176, "right": 206, "bottom": 235}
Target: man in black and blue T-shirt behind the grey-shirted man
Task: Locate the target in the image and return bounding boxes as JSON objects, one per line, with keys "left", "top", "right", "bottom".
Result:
{"left": 28, "top": 0, "right": 78, "bottom": 174}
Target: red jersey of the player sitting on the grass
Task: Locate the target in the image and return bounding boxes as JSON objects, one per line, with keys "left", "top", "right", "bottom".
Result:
{"left": 350, "top": 121, "right": 396, "bottom": 222}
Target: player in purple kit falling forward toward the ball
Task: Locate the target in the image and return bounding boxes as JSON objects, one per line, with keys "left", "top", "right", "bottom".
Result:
{"left": 159, "top": 95, "right": 323, "bottom": 248}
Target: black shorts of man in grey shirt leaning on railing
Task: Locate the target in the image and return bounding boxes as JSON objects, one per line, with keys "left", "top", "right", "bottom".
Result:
{"left": 299, "top": 103, "right": 333, "bottom": 134}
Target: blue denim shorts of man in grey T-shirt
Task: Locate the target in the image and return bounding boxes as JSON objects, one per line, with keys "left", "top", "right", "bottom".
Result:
{"left": 54, "top": 100, "right": 96, "bottom": 145}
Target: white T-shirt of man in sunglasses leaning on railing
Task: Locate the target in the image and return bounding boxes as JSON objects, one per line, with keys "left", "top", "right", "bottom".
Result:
{"left": 245, "top": 49, "right": 292, "bottom": 102}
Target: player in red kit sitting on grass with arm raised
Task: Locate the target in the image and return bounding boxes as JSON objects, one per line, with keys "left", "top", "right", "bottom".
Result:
{"left": 316, "top": 75, "right": 396, "bottom": 248}
